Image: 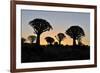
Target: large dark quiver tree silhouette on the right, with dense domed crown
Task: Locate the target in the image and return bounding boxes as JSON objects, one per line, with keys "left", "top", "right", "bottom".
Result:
{"left": 65, "top": 26, "right": 85, "bottom": 45}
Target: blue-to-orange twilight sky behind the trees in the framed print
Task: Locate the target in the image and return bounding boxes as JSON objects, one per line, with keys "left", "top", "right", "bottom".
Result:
{"left": 21, "top": 10, "right": 90, "bottom": 45}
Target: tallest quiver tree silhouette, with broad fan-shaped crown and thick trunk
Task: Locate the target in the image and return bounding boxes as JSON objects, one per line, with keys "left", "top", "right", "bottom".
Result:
{"left": 29, "top": 18, "right": 53, "bottom": 45}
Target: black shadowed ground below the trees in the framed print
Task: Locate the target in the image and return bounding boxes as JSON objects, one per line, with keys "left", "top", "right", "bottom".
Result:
{"left": 21, "top": 43, "right": 90, "bottom": 63}
